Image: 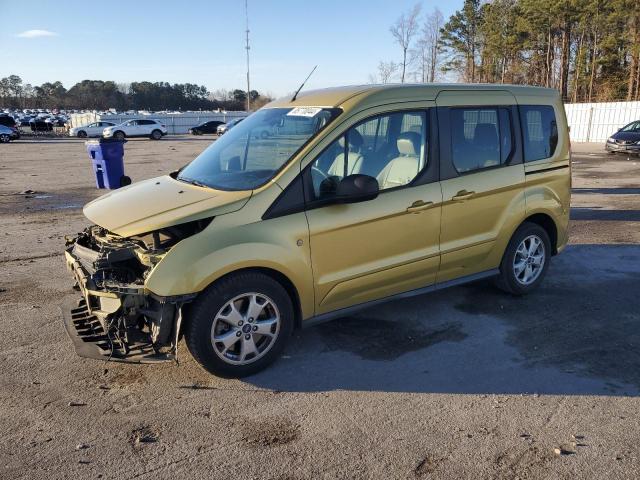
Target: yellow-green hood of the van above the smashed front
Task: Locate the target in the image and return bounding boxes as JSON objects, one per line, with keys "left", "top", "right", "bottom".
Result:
{"left": 83, "top": 176, "right": 251, "bottom": 237}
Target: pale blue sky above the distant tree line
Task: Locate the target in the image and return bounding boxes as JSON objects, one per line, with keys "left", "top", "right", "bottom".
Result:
{"left": 0, "top": 0, "right": 462, "bottom": 97}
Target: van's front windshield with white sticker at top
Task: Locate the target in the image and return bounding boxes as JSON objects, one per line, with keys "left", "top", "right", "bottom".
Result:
{"left": 177, "top": 107, "right": 340, "bottom": 190}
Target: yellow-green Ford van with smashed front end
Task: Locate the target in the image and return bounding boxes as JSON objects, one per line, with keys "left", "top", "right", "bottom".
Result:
{"left": 65, "top": 85, "right": 571, "bottom": 376}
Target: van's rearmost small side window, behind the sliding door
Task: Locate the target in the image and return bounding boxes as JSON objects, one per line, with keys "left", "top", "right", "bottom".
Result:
{"left": 519, "top": 105, "right": 558, "bottom": 162}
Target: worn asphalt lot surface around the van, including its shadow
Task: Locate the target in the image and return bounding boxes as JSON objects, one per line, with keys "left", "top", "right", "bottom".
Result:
{"left": 0, "top": 137, "right": 640, "bottom": 479}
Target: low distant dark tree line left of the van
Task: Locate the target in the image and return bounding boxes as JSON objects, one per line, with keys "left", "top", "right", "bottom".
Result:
{"left": 0, "top": 75, "right": 271, "bottom": 111}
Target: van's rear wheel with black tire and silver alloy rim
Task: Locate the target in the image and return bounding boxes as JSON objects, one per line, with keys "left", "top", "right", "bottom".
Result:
{"left": 496, "top": 222, "right": 551, "bottom": 295}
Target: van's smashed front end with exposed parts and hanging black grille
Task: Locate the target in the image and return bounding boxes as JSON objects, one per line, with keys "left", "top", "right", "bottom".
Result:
{"left": 63, "top": 224, "right": 198, "bottom": 363}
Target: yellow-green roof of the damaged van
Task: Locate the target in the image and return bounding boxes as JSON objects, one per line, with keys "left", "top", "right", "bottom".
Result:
{"left": 268, "top": 83, "right": 559, "bottom": 108}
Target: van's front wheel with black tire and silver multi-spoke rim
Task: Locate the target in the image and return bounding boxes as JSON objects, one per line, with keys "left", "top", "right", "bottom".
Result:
{"left": 185, "top": 272, "right": 294, "bottom": 378}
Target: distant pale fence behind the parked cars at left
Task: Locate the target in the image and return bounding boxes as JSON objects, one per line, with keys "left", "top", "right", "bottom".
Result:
{"left": 70, "top": 112, "right": 248, "bottom": 134}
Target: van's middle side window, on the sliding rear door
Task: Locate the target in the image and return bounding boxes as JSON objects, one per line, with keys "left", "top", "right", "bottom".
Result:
{"left": 450, "top": 108, "right": 513, "bottom": 173}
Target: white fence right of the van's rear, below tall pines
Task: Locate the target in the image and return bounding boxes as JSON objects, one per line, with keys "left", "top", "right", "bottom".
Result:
{"left": 564, "top": 102, "right": 640, "bottom": 142}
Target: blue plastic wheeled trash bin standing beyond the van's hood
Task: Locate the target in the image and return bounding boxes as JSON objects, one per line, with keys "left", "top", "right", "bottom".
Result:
{"left": 85, "top": 138, "right": 131, "bottom": 190}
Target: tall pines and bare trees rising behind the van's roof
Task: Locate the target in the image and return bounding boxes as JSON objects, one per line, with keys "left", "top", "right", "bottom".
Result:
{"left": 370, "top": 0, "right": 640, "bottom": 102}
